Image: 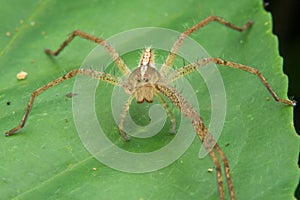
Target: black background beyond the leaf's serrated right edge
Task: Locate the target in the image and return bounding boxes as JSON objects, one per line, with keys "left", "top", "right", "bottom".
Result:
{"left": 264, "top": 0, "right": 300, "bottom": 199}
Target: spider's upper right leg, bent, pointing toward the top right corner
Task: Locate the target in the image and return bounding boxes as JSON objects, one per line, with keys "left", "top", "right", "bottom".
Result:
{"left": 160, "top": 15, "right": 253, "bottom": 76}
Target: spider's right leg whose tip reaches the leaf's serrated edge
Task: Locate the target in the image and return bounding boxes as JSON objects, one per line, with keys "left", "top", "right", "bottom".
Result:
{"left": 168, "top": 58, "right": 296, "bottom": 106}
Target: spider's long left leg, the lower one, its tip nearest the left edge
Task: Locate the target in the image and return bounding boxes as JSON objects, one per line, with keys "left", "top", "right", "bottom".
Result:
{"left": 5, "top": 69, "right": 121, "bottom": 136}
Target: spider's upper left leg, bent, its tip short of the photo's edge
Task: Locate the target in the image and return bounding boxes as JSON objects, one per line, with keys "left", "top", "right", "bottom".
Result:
{"left": 45, "top": 30, "right": 131, "bottom": 76}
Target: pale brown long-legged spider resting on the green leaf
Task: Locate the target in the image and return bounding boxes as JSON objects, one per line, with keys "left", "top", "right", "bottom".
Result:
{"left": 5, "top": 16, "right": 296, "bottom": 200}
